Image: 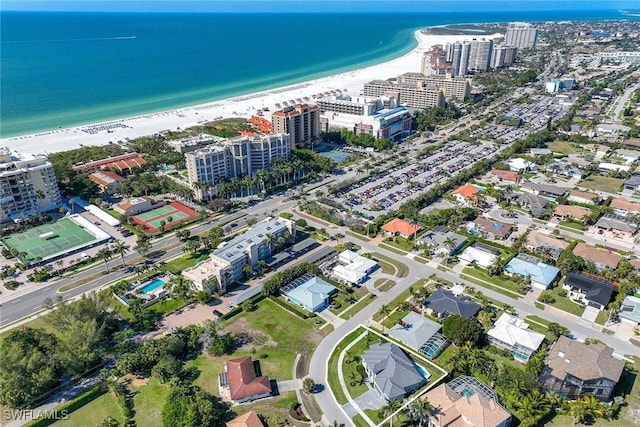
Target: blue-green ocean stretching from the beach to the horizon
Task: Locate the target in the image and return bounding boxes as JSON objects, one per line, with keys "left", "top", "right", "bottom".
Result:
{"left": 0, "top": 10, "right": 630, "bottom": 138}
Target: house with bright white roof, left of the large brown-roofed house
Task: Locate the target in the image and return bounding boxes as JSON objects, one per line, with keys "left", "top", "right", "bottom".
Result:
{"left": 487, "top": 313, "right": 544, "bottom": 363}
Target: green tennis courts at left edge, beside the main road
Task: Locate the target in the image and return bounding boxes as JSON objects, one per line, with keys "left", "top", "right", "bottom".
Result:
{"left": 2, "top": 218, "right": 96, "bottom": 262}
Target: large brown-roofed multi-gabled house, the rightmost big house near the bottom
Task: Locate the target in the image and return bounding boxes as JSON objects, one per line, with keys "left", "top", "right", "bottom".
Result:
{"left": 540, "top": 335, "right": 624, "bottom": 401}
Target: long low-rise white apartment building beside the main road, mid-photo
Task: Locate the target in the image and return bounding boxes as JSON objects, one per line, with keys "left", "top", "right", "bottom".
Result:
{"left": 182, "top": 218, "right": 296, "bottom": 293}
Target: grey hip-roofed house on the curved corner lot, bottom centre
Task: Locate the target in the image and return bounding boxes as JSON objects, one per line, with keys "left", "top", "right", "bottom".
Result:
{"left": 362, "top": 343, "right": 427, "bottom": 402}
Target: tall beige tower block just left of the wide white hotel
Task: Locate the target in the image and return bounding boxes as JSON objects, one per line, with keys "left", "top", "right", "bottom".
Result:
{"left": 271, "top": 104, "right": 320, "bottom": 147}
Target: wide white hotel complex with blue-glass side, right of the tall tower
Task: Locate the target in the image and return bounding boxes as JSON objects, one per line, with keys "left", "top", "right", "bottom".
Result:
{"left": 318, "top": 94, "right": 412, "bottom": 141}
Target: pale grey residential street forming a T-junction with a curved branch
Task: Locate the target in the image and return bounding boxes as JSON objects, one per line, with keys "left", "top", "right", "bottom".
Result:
{"left": 305, "top": 217, "right": 640, "bottom": 426}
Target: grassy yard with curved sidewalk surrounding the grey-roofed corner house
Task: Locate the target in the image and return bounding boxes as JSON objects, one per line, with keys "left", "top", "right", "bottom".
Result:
{"left": 327, "top": 325, "right": 447, "bottom": 426}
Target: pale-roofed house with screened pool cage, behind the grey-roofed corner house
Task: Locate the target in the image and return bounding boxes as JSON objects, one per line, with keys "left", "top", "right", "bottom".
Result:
{"left": 389, "top": 311, "right": 448, "bottom": 359}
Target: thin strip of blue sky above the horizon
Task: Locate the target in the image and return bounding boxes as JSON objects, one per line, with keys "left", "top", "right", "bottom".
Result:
{"left": 5, "top": 0, "right": 640, "bottom": 13}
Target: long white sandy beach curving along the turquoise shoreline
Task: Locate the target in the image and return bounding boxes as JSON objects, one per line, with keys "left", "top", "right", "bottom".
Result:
{"left": 0, "top": 31, "right": 500, "bottom": 154}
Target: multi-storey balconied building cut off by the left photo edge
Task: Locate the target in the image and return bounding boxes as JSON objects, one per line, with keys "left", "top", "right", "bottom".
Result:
{"left": 0, "top": 147, "right": 62, "bottom": 222}
